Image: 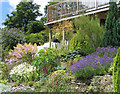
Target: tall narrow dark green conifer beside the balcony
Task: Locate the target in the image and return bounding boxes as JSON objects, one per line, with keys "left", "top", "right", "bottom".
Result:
{"left": 103, "top": 2, "right": 120, "bottom": 47}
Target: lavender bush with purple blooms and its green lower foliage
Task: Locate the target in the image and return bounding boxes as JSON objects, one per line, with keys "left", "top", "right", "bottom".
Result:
{"left": 71, "top": 47, "right": 117, "bottom": 78}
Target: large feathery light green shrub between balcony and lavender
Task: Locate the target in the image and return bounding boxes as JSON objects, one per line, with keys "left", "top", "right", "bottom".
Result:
{"left": 69, "top": 16, "right": 104, "bottom": 55}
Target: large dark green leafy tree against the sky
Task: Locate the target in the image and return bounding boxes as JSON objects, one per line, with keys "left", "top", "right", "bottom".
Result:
{"left": 3, "top": 0, "right": 42, "bottom": 32}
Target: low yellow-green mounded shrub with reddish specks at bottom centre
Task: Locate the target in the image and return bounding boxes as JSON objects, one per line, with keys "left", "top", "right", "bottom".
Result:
{"left": 47, "top": 70, "right": 74, "bottom": 92}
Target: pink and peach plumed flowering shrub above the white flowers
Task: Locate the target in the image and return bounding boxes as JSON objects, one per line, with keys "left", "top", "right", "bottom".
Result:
{"left": 5, "top": 43, "right": 37, "bottom": 63}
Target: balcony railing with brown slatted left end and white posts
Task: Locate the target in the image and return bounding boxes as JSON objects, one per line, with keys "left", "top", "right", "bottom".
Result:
{"left": 47, "top": 0, "right": 119, "bottom": 22}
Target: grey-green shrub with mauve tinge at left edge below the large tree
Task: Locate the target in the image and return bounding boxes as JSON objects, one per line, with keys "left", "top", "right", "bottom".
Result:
{"left": 2, "top": 28, "right": 26, "bottom": 50}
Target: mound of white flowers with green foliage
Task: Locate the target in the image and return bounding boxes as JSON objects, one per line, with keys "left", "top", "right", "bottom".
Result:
{"left": 9, "top": 63, "right": 36, "bottom": 81}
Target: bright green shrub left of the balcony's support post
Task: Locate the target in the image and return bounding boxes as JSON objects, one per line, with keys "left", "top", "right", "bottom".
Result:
{"left": 26, "top": 30, "right": 49, "bottom": 45}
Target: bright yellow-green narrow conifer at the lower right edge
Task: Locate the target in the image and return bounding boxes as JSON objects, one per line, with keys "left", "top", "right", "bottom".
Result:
{"left": 113, "top": 48, "right": 120, "bottom": 93}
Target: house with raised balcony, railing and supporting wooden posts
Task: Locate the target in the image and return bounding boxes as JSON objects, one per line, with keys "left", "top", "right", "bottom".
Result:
{"left": 45, "top": 0, "right": 120, "bottom": 47}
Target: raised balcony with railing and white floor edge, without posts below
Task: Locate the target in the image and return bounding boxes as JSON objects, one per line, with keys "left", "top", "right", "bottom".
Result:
{"left": 45, "top": 0, "right": 119, "bottom": 25}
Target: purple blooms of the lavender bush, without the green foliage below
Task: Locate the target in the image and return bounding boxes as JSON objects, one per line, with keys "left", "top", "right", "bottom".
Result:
{"left": 71, "top": 47, "right": 117, "bottom": 75}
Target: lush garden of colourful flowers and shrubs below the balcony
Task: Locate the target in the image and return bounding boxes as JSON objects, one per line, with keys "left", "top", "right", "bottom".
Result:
{"left": 0, "top": 2, "right": 120, "bottom": 93}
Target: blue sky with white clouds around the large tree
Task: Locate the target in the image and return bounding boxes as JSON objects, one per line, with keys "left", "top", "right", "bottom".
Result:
{"left": 0, "top": 0, "right": 50, "bottom": 28}
